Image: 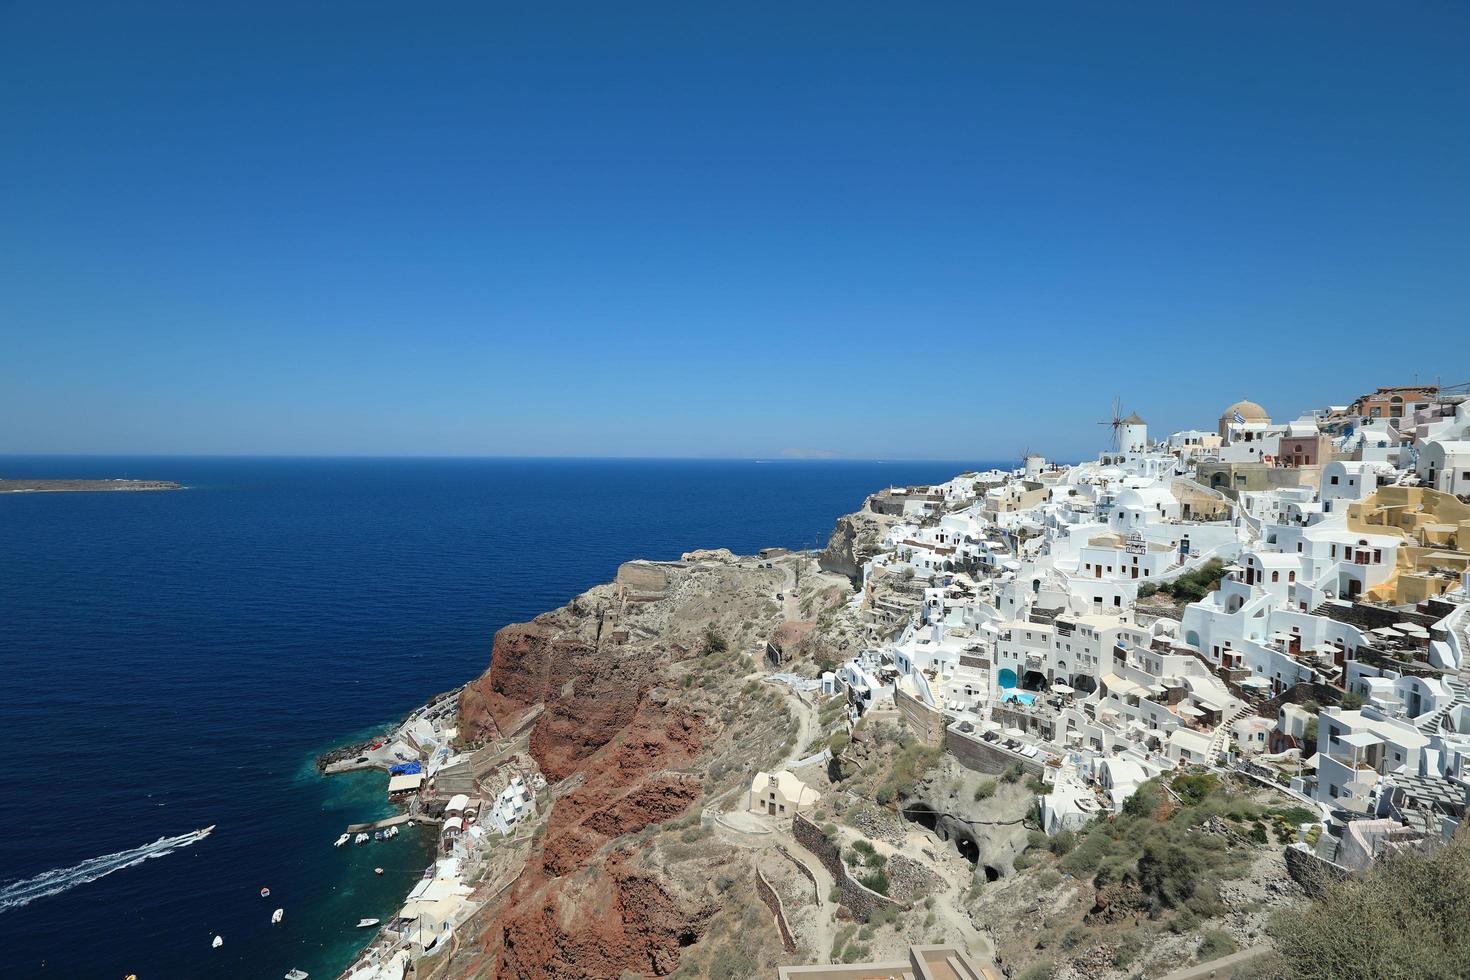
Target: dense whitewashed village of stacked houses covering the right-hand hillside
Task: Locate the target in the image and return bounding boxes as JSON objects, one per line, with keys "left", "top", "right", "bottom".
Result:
{"left": 782, "top": 386, "right": 1470, "bottom": 910}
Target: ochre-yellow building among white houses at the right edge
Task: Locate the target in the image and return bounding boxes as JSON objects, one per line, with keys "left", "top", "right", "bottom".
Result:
{"left": 1348, "top": 486, "right": 1470, "bottom": 605}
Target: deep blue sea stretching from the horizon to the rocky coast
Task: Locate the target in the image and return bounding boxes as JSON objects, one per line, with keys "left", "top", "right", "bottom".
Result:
{"left": 0, "top": 457, "right": 983, "bottom": 980}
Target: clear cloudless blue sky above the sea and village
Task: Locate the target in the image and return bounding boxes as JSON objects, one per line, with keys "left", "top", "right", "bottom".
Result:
{"left": 0, "top": 0, "right": 1470, "bottom": 458}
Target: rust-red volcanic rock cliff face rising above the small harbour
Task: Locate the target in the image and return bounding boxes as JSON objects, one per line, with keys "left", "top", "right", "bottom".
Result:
{"left": 460, "top": 604, "right": 714, "bottom": 980}
